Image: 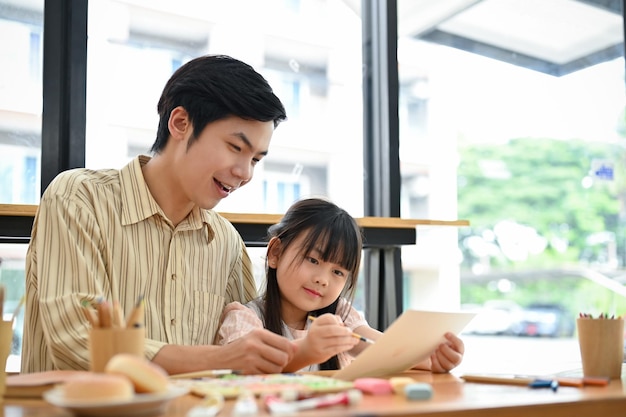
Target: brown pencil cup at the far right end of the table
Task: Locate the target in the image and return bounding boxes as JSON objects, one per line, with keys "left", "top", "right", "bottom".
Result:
{"left": 576, "top": 318, "right": 624, "bottom": 379}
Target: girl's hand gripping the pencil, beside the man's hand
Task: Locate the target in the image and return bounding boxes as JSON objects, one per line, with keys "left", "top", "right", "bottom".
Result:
{"left": 301, "top": 313, "right": 359, "bottom": 363}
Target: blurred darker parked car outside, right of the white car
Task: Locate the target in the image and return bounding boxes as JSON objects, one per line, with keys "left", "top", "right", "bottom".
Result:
{"left": 518, "top": 304, "right": 576, "bottom": 337}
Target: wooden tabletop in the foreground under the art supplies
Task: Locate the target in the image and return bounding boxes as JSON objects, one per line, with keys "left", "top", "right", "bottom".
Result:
{"left": 4, "top": 371, "right": 626, "bottom": 417}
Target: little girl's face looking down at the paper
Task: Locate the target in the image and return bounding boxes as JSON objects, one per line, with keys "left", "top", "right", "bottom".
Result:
{"left": 268, "top": 234, "right": 349, "bottom": 327}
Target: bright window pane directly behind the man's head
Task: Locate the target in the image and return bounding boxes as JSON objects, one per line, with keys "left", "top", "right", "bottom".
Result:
{"left": 86, "top": 0, "right": 363, "bottom": 216}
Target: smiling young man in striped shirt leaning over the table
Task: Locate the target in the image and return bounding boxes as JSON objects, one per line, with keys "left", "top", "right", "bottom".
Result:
{"left": 22, "top": 56, "right": 294, "bottom": 374}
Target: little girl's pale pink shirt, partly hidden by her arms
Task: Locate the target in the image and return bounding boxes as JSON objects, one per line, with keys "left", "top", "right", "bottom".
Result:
{"left": 217, "top": 297, "right": 368, "bottom": 372}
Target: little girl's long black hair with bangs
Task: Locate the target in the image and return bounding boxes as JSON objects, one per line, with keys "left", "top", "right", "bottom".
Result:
{"left": 262, "top": 198, "right": 363, "bottom": 370}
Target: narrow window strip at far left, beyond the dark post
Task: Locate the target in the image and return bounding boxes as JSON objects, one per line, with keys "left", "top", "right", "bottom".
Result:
{"left": 0, "top": 0, "right": 43, "bottom": 372}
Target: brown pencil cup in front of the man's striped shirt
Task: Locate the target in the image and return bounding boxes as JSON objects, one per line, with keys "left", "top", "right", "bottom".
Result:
{"left": 89, "top": 327, "right": 145, "bottom": 372}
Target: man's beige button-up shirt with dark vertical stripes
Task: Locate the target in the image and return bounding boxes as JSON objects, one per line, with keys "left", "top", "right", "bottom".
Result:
{"left": 21, "top": 156, "right": 256, "bottom": 372}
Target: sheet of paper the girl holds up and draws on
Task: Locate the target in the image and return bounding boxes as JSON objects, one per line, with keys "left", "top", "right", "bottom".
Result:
{"left": 333, "top": 310, "right": 476, "bottom": 381}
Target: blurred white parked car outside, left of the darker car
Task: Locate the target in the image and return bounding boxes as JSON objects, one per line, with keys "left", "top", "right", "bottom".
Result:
{"left": 464, "top": 300, "right": 522, "bottom": 335}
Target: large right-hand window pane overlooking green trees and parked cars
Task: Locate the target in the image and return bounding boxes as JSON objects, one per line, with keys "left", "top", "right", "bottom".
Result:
{"left": 398, "top": 0, "right": 626, "bottom": 370}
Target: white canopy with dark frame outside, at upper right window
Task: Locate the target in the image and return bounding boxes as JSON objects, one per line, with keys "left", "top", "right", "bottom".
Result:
{"left": 346, "top": 0, "right": 624, "bottom": 76}
